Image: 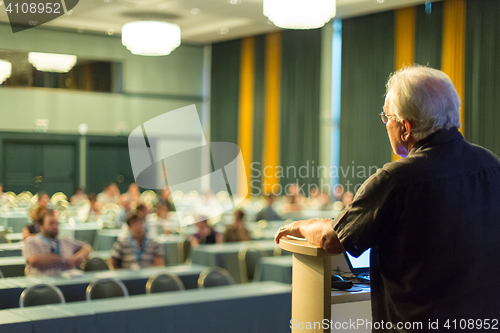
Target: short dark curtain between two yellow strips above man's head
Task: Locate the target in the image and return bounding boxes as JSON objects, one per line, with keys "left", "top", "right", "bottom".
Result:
{"left": 415, "top": 2, "right": 443, "bottom": 69}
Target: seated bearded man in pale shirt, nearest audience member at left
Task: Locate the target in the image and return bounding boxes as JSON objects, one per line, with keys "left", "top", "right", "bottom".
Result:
{"left": 23, "top": 209, "right": 92, "bottom": 276}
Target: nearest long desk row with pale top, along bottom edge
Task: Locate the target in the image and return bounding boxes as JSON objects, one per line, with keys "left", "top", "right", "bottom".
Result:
{"left": 0, "top": 282, "right": 291, "bottom": 333}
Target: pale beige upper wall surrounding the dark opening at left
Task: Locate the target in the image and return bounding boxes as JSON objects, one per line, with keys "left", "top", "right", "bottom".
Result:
{"left": 0, "top": 25, "right": 203, "bottom": 135}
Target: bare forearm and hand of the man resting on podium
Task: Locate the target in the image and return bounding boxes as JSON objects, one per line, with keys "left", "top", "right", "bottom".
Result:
{"left": 274, "top": 219, "right": 345, "bottom": 254}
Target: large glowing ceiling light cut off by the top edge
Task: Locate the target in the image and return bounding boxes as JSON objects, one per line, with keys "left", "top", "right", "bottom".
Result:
{"left": 264, "top": 0, "right": 336, "bottom": 29}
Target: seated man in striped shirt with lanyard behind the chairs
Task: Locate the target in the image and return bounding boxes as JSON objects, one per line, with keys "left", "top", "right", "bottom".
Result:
{"left": 111, "top": 215, "right": 165, "bottom": 269}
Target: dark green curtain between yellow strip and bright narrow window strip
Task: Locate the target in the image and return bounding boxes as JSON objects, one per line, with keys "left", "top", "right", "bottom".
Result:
{"left": 280, "top": 29, "right": 321, "bottom": 194}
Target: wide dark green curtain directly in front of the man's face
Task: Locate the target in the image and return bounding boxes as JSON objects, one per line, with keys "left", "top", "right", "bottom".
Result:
{"left": 338, "top": 11, "right": 394, "bottom": 192}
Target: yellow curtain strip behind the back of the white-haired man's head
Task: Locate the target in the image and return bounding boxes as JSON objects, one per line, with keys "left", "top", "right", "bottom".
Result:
{"left": 441, "top": 0, "right": 467, "bottom": 134}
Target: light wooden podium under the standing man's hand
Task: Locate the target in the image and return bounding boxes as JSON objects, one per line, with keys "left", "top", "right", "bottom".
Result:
{"left": 279, "top": 238, "right": 333, "bottom": 333}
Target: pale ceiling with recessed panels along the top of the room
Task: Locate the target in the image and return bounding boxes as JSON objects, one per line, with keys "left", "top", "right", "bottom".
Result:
{"left": 0, "top": 0, "right": 436, "bottom": 44}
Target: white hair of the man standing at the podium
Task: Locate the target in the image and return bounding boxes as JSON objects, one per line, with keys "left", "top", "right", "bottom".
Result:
{"left": 386, "top": 65, "right": 460, "bottom": 141}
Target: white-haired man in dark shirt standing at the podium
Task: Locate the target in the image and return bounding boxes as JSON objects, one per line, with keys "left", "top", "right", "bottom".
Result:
{"left": 276, "top": 66, "right": 500, "bottom": 332}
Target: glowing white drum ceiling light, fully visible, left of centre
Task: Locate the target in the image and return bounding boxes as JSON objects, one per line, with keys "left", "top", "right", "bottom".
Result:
{"left": 122, "top": 21, "right": 181, "bottom": 56}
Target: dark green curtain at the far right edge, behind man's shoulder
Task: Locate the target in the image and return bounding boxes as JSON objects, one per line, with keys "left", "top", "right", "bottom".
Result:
{"left": 463, "top": 0, "right": 500, "bottom": 156}
